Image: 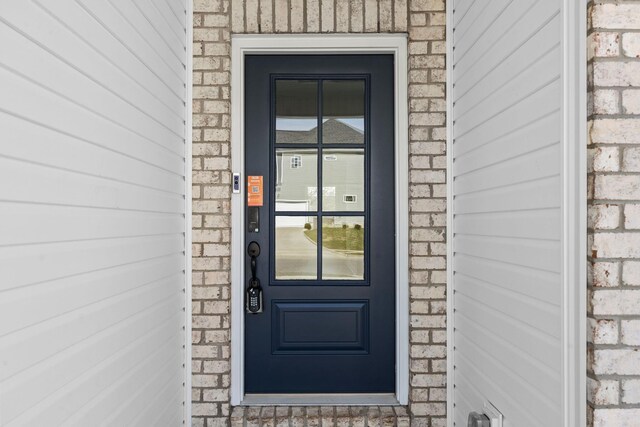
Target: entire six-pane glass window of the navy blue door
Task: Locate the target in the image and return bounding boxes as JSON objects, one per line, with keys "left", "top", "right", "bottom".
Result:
{"left": 275, "top": 80, "right": 366, "bottom": 280}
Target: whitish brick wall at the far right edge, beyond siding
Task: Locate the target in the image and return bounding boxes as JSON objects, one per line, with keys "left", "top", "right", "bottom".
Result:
{"left": 587, "top": 1, "right": 640, "bottom": 427}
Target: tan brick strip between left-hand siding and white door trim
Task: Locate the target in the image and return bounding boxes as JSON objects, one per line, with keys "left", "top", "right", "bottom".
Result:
{"left": 192, "top": 0, "right": 231, "bottom": 427}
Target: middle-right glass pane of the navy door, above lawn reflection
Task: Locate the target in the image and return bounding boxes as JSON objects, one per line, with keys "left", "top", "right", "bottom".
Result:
{"left": 322, "top": 148, "right": 364, "bottom": 212}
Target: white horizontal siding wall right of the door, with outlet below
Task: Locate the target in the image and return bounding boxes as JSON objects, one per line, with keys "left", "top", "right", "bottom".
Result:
{"left": 449, "top": 0, "right": 564, "bottom": 427}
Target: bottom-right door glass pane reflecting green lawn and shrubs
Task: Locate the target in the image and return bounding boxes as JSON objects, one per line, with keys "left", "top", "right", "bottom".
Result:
{"left": 322, "top": 216, "right": 364, "bottom": 280}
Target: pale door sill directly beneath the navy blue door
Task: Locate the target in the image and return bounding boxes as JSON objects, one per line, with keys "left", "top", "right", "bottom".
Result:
{"left": 240, "top": 393, "right": 400, "bottom": 406}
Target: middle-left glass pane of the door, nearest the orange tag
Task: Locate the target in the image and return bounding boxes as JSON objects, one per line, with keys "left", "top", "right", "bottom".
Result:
{"left": 275, "top": 148, "right": 318, "bottom": 212}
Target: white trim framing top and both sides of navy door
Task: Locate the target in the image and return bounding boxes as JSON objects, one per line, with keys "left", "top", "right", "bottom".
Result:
{"left": 231, "top": 34, "right": 409, "bottom": 405}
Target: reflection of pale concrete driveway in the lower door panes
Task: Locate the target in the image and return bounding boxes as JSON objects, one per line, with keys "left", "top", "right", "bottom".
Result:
{"left": 276, "top": 227, "right": 364, "bottom": 279}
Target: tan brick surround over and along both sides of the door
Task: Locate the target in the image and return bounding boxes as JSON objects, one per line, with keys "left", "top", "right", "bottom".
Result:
{"left": 192, "top": 0, "right": 446, "bottom": 427}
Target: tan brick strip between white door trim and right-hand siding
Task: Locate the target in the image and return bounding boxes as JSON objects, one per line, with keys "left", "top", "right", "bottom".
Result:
{"left": 409, "top": 0, "right": 447, "bottom": 427}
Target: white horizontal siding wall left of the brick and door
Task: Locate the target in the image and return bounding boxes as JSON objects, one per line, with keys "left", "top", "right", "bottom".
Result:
{"left": 0, "top": 0, "right": 191, "bottom": 427}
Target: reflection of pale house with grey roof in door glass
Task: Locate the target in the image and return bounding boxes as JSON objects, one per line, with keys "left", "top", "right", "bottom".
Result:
{"left": 276, "top": 119, "right": 365, "bottom": 221}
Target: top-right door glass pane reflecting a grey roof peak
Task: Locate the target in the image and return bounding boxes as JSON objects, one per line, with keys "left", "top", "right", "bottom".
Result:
{"left": 322, "top": 80, "right": 364, "bottom": 144}
